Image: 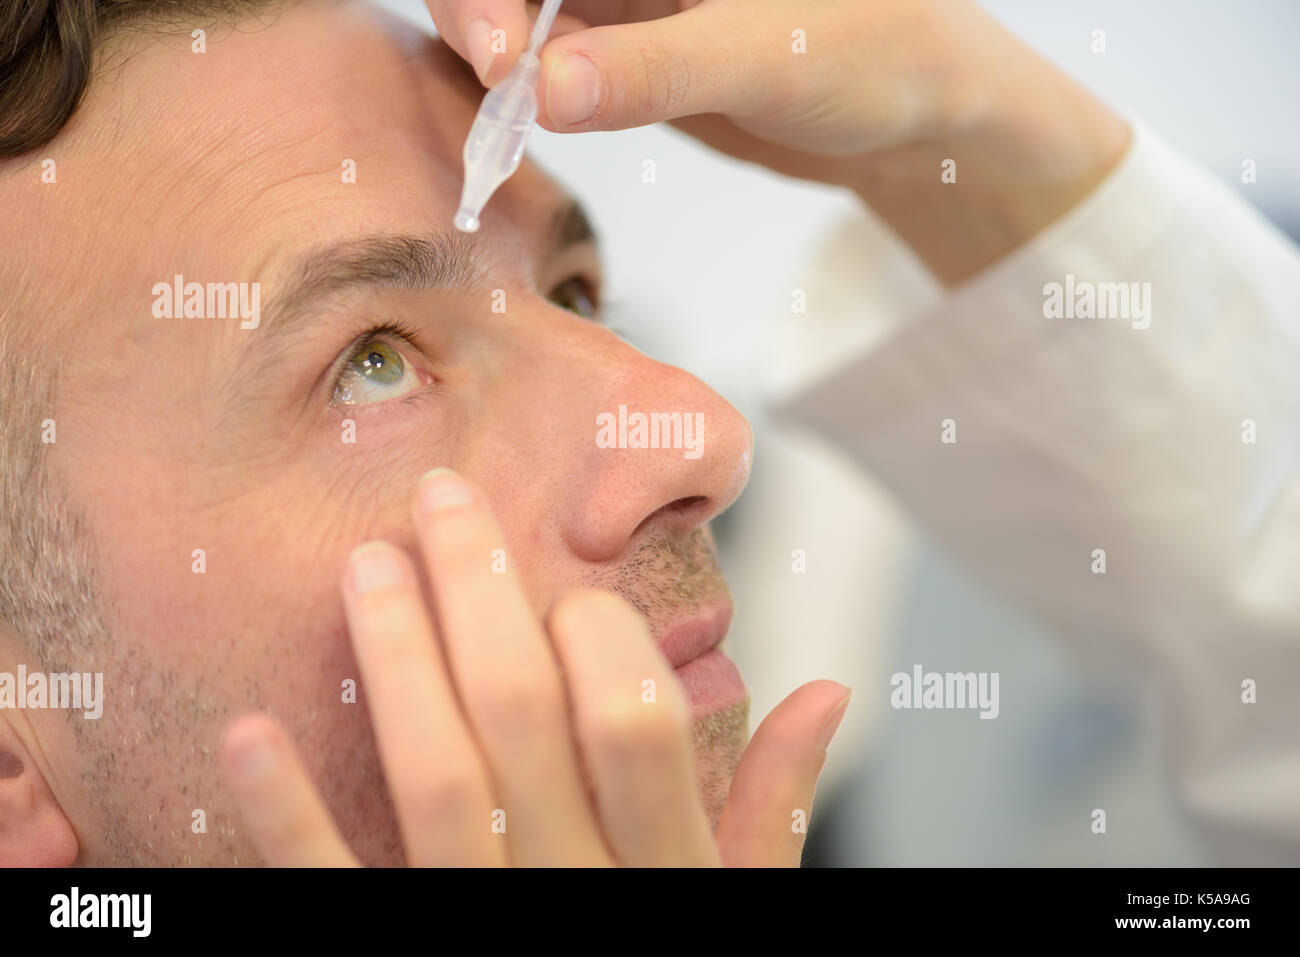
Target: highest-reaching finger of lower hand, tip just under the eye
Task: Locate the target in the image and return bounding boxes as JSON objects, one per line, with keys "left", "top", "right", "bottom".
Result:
{"left": 415, "top": 469, "right": 608, "bottom": 866}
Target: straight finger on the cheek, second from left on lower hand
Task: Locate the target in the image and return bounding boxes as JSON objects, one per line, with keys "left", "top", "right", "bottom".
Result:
{"left": 343, "top": 542, "right": 506, "bottom": 867}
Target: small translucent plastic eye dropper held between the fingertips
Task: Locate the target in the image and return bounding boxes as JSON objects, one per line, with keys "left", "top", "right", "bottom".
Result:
{"left": 452, "top": 0, "right": 560, "bottom": 233}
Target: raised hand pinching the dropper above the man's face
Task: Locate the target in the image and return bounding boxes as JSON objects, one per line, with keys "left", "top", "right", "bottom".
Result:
{"left": 426, "top": 0, "right": 1128, "bottom": 283}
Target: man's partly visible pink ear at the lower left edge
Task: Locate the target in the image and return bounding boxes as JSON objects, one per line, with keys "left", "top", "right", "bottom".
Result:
{"left": 0, "top": 720, "right": 79, "bottom": 867}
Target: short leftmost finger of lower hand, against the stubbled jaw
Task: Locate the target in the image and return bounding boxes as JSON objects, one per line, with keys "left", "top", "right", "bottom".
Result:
{"left": 221, "top": 714, "right": 358, "bottom": 867}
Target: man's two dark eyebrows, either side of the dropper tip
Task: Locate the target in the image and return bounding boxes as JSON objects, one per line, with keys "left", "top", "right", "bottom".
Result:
{"left": 250, "top": 200, "right": 598, "bottom": 350}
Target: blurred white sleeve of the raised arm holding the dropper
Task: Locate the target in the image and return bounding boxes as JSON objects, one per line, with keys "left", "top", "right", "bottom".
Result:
{"left": 779, "top": 117, "right": 1300, "bottom": 865}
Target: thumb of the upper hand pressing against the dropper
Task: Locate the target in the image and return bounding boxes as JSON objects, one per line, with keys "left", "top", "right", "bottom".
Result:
{"left": 537, "top": 4, "right": 762, "bottom": 133}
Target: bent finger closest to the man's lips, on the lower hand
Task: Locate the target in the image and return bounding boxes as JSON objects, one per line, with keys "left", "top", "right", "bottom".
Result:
{"left": 547, "top": 590, "right": 720, "bottom": 867}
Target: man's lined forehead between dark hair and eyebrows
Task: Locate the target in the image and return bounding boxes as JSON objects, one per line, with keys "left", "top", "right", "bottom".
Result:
{"left": 12, "top": 3, "right": 562, "bottom": 325}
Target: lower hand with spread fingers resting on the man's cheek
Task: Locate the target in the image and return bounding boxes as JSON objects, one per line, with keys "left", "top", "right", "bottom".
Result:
{"left": 222, "top": 469, "right": 848, "bottom": 866}
